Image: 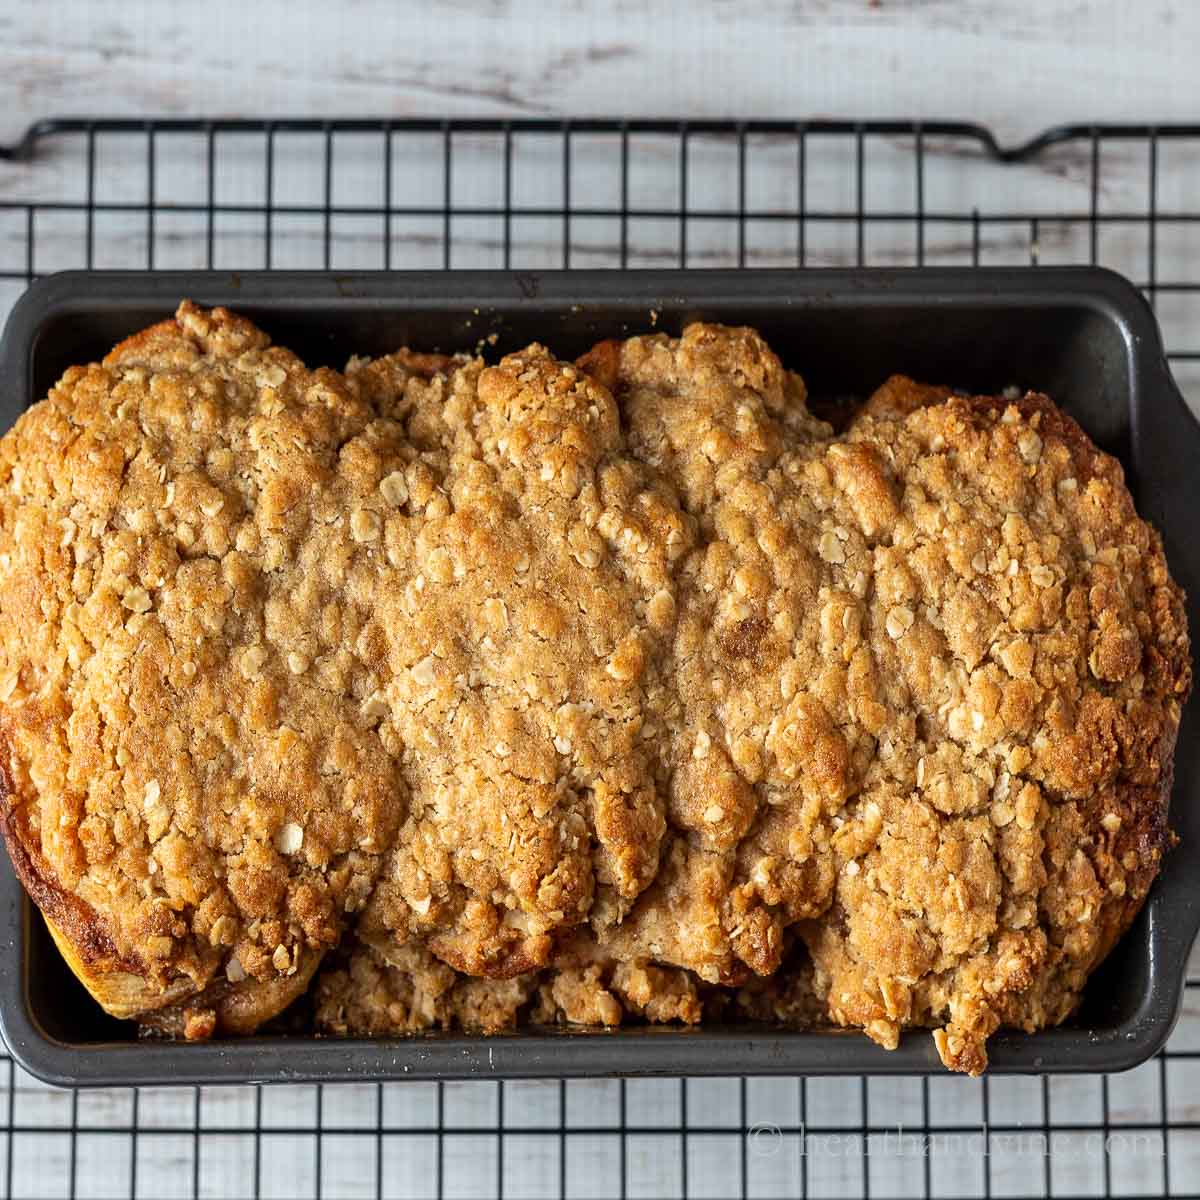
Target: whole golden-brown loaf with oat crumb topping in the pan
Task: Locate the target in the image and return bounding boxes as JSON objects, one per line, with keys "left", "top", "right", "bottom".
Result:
{"left": 0, "top": 302, "right": 1190, "bottom": 1073}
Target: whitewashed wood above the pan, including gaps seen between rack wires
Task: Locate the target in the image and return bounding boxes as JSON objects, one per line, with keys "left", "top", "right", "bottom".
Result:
{"left": 0, "top": 0, "right": 1200, "bottom": 304}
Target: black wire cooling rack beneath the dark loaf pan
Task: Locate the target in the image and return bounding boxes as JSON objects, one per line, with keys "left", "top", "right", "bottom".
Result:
{"left": 0, "top": 120, "right": 1200, "bottom": 1200}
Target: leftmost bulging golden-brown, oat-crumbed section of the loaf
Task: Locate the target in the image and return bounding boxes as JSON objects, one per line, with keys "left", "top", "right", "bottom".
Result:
{"left": 0, "top": 305, "right": 403, "bottom": 1022}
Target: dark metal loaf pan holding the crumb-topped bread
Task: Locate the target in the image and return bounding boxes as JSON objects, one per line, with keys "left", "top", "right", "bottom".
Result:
{"left": 0, "top": 269, "right": 1200, "bottom": 1084}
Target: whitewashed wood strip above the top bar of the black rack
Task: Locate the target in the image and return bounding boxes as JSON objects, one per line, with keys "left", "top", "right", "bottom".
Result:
{"left": 0, "top": 0, "right": 1200, "bottom": 139}
